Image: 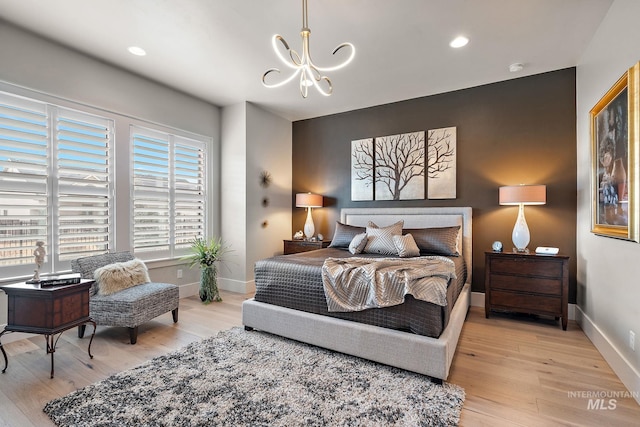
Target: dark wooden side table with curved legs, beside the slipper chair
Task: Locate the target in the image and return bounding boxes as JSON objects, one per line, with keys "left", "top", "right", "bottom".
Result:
{"left": 0, "top": 280, "right": 96, "bottom": 378}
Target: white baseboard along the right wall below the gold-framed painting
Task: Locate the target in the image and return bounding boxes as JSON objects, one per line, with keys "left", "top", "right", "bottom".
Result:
{"left": 576, "top": 307, "right": 640, "bottom": 404}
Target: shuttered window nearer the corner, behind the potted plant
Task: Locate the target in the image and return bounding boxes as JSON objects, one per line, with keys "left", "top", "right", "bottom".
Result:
{"left": 131, "top": 126, "right": 206, "bottom": 258}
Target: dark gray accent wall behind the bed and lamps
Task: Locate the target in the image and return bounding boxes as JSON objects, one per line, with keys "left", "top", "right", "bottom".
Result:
{"left": 292, "top": 68, "right": 577, "bottom": 302}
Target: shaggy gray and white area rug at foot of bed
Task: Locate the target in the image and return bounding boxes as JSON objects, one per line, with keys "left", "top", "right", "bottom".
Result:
{"left": 44, "top": 328, "right": 464, "bottom": 427}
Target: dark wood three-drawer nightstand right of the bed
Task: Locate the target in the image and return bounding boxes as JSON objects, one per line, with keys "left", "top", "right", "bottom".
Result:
{"left": 484, "top": 252, "right": 569, "bottom": 330}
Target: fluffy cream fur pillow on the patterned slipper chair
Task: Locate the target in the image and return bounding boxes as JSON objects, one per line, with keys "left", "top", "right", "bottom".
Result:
{"left": 93, "top": 258, "right": 151, "bottom": 295}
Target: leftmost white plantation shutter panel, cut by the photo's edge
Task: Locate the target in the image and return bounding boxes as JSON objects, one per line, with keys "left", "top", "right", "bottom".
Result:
{"left": 0, "top": 93, "right": 50, "bottom": 275}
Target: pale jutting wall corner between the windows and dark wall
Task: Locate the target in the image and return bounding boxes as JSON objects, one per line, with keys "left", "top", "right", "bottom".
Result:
{"left": 219, "top": 102, "right": 292, "bottom": 293}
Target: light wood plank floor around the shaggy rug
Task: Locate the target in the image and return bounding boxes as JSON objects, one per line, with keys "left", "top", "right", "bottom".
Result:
{"left": 0, "top": 292, "right": 640, "bottom": 427}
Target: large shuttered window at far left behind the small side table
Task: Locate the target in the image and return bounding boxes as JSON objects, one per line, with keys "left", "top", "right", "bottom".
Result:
{"left": 0, "top": 93, "right": 114, "bottom": 276}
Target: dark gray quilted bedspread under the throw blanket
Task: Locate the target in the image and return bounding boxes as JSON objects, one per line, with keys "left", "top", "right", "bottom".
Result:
{"left": 255, "top": 248, "right": 467, "bottom": 338}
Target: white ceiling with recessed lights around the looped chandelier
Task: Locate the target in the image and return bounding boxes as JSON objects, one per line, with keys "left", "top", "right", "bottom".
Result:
{"left": 0, "top": 0, "right": 612, "bottom": 121}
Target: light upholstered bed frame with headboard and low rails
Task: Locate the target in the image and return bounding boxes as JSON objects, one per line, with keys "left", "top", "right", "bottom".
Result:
{"left": 242, "top": 207, "right": 472, "bottom": 380}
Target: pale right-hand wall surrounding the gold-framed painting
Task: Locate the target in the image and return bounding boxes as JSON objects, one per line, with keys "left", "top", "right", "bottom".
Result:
{"left": 576, "top": 0, "right": 640, "bottom": 402}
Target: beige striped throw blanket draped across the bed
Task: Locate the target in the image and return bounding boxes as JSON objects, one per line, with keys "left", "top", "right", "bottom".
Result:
{"left": 322, "top": 256, "right": 456, "bottom": 312}
